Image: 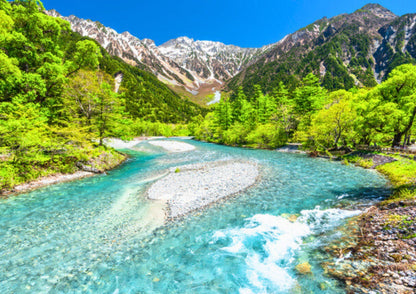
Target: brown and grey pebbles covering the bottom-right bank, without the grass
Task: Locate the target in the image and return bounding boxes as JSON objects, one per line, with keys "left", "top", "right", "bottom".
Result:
{"left": 325, "top": 202, "right": 416, "bottom": 293}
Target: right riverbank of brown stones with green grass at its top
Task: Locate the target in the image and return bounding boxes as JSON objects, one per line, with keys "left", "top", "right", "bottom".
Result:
{"left": 324, "top": 152, "right": 416, "bottom": 293}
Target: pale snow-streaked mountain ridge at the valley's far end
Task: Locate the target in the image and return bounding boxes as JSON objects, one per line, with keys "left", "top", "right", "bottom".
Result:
{"left": 47, "top": 10, "right": 268, "bottom": 95}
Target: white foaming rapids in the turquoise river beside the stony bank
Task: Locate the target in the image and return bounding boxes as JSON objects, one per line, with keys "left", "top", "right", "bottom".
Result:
{"left": 213, "top": 206, "right": 360, "bottom": 294}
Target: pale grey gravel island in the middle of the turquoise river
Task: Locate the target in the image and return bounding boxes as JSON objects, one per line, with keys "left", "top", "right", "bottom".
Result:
{"left": 147, "top": 161, "right": 259, "bottom": 219}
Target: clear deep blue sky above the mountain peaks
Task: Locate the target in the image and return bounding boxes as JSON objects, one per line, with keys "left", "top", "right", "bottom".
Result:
{"left": 42, "top": 0, "right": 416, "bottom": 47}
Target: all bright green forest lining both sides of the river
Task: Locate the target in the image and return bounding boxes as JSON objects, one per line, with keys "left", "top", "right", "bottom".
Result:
{"left": 0, "top": 0, "right": 416, "bottom": 189}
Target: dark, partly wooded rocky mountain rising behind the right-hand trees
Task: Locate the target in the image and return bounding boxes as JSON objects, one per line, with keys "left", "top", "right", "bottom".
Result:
{"left": 227, "top": 4, "right": 416, "bottom": 91}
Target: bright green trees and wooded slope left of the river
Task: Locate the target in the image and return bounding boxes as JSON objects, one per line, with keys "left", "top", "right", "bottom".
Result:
{"left": 0, "top": 0, "right": 202, "bottom": 190}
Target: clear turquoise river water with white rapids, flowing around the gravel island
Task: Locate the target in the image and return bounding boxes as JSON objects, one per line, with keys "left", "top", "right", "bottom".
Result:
{"left": 0, "top": 141, "right": 387, "bottom": 293}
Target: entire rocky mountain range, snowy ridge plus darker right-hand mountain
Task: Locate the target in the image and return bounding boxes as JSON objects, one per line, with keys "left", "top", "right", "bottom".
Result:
{"left": 49, "top": 4, "right": 416, "bottom": 95}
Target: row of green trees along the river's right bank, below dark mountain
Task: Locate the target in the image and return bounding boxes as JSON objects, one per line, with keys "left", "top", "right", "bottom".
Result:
{"left": 194, "top": 64, "right": 416, "bottom": 152}
